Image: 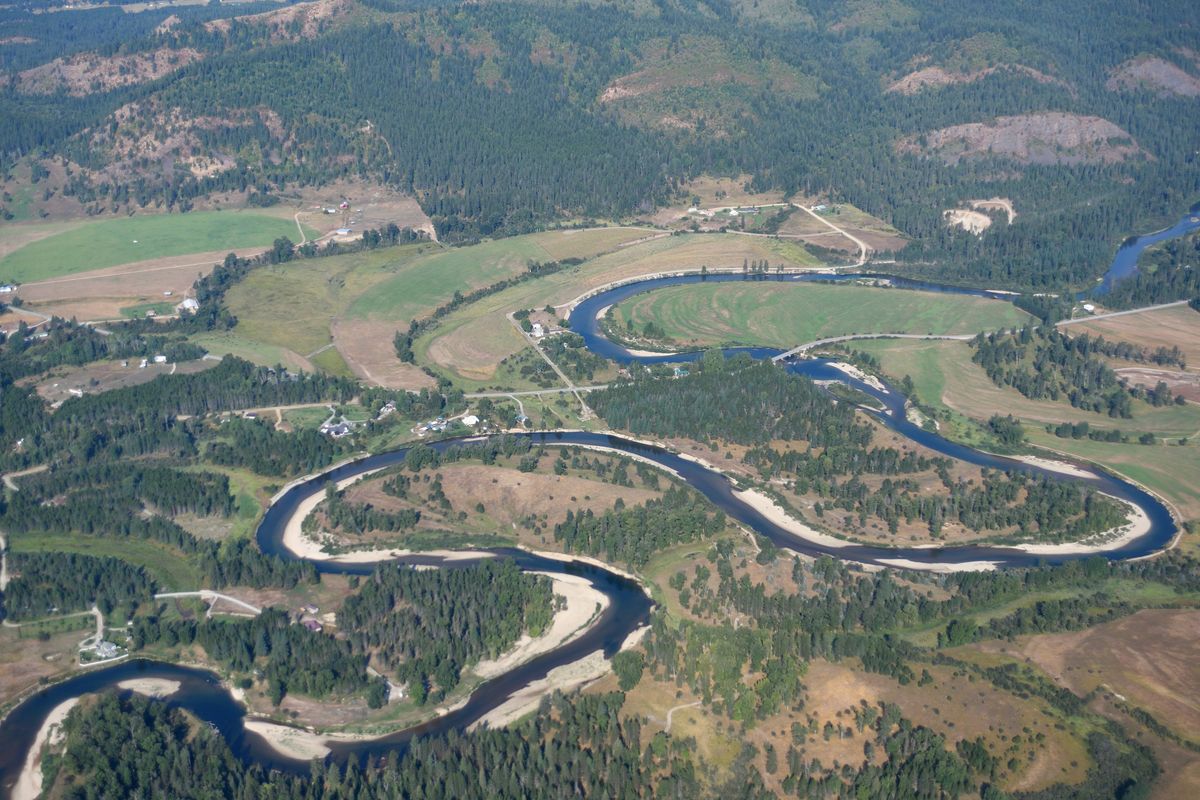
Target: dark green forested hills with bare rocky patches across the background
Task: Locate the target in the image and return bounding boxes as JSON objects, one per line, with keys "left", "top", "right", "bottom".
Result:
{"left": 0, "top": 0, "right": 1200, "bottom": 288}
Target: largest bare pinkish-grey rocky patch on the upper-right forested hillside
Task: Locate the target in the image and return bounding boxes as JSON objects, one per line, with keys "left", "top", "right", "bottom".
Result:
{"left": 896, "top": 112, "right": 1147, "bottom": 164}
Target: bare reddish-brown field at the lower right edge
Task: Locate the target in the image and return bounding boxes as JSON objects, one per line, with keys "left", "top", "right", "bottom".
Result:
{"left": 982, "top": 609, "right": 1200, "bottom": 744}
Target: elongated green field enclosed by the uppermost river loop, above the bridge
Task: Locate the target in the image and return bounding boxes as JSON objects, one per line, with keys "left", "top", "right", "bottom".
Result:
{"left": 617, "top": 282, "right": 1030, "bottom": 347}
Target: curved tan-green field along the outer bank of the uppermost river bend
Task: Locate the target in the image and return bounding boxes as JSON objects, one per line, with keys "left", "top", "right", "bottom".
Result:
{"left": 414, "top": 234, "right": 821, "bottom": 389}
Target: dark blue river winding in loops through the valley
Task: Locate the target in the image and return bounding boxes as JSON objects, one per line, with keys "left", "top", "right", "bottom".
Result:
{"left": 0, "top": 205, "right": 1200, "bottom": 798}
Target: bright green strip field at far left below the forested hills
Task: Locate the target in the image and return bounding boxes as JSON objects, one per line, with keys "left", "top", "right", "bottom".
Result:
{"left": 0, "top": 211, "right": 316, "bottom": 283}
